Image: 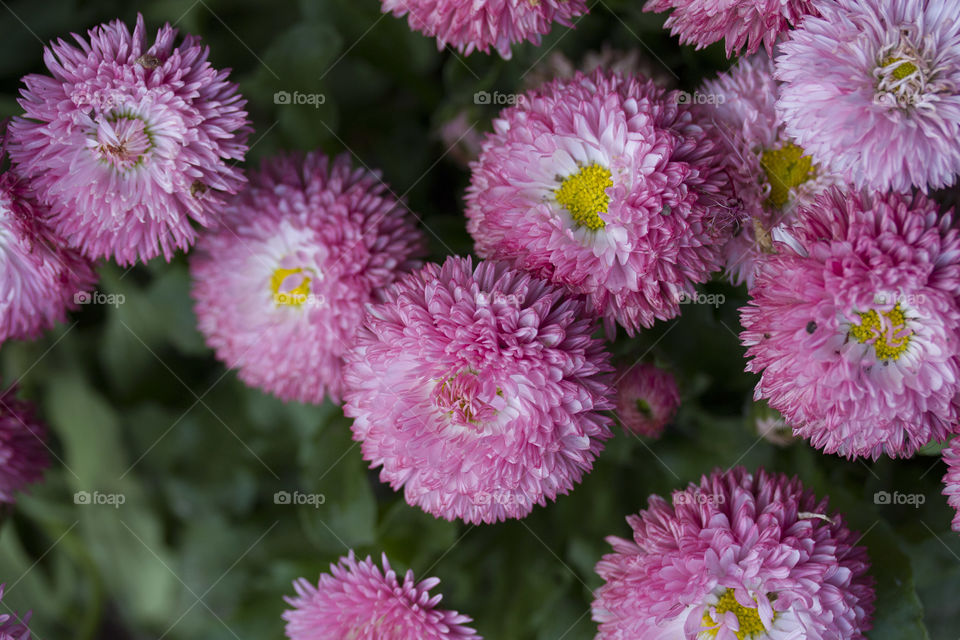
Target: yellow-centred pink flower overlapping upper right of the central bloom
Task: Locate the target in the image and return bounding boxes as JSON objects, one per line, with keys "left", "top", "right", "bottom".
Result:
{"left": 466, "top": 70, "right": 733, "bottom": 334}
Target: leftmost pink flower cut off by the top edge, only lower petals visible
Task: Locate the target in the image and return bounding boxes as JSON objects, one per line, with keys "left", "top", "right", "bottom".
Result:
{"left": 381, "top": 0, "right": 587, "bottom": 60}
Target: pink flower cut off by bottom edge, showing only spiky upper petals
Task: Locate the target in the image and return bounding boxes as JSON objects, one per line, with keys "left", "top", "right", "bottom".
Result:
{"left": 283, "top": 551, "right": 481, "bottom": 640}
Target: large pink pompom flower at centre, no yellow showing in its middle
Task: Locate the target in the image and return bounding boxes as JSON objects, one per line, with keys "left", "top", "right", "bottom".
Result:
{"left": 344, "top": 257, "right": 613, "bottom": 524}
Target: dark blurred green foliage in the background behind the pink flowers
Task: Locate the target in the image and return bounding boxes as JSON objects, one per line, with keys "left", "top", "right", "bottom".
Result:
{"left": 0, "top": 0, "right": 960, "bottom": 640}
